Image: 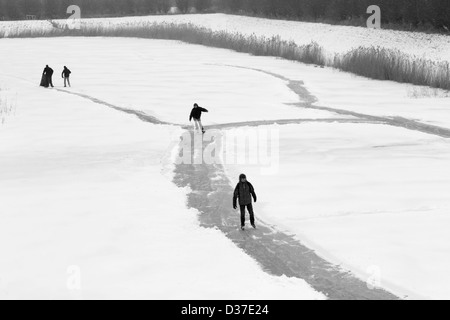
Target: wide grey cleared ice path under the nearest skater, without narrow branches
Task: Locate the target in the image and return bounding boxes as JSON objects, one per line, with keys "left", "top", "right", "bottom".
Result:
{"left": 174, "top": 130, "right": 398, "bottom": 300}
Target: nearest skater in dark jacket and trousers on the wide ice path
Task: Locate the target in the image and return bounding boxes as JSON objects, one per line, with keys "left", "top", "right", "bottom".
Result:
{"left": 233, "top": 174, "right": 257, "bottom": 230}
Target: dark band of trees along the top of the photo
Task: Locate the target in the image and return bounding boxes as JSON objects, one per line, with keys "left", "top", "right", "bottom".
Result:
{"left": 0, "top": 0, "right": 450, "bottom": 31}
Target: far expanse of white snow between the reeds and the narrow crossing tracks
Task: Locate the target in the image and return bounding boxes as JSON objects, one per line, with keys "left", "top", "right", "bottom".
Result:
{"left": 0, "top": 38, "right": 450, "bottom": 128}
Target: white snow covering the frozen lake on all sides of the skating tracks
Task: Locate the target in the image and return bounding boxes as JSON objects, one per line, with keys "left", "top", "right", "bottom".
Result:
{"left": 0, "top": 37, "right": 450, "bottom": 298}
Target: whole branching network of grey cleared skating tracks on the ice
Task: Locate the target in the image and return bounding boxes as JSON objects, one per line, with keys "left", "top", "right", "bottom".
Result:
{"left": 52, "top": 66, "right": 450, "bottom": 300}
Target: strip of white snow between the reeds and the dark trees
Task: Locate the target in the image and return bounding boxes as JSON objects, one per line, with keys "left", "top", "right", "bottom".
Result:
{"left": 0, "top": 14, "right": 450, "bottom": 61}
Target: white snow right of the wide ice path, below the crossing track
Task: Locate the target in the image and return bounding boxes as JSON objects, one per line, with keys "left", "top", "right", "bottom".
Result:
{"left": 223, "top": 123, "right": 450, "bottom": 299}
